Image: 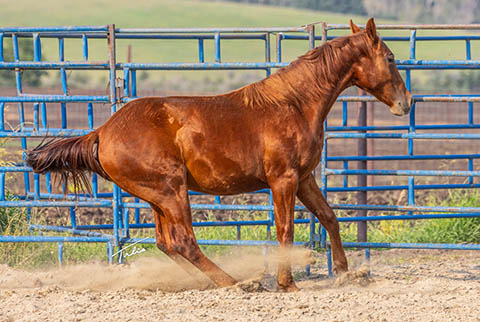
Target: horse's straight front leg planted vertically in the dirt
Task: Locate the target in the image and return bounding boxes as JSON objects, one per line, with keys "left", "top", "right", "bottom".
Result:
{"left": 270, "top": 174, "right": 298, "bottom": 292}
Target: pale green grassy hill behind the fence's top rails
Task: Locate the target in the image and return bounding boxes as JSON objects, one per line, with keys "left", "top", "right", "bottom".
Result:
{"left": 0, "top": 0, "right": 480, "bottom": 92}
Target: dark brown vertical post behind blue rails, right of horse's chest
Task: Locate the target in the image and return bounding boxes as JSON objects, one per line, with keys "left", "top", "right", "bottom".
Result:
{"left": 357, "top": 89, "right": 367, "bottom": 242}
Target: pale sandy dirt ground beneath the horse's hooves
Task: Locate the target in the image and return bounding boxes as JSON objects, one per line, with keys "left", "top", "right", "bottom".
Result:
{"left": 0, "top": 250, "right": 480, "bottom": 322}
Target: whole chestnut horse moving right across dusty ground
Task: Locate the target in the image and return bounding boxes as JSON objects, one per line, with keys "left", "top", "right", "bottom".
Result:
{"left": 27, "top": 19, "right": 411, "bottom": 291}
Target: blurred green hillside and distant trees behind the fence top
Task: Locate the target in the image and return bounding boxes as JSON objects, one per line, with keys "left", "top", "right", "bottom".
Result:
{"left": 0, "top": 0, "right": 480, "bottom": 93}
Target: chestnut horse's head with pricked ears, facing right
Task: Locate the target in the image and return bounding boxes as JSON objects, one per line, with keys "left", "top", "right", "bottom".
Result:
{"left": 350, "top": 18, "right": 412, "bottom": 116}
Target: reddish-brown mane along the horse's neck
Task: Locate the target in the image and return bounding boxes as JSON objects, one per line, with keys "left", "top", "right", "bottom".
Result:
{"left": 238, "top": 32, "right": 367, "bottom": 108}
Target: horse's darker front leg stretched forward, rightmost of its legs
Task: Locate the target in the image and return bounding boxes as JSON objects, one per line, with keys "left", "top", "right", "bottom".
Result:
{"left": 297, "top": 174, "right": 348, "bottom": 273}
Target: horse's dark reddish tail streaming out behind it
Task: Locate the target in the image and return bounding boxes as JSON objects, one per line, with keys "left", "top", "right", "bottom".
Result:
{"left": 26, "top": 131, "right": 109, "bottom": 192}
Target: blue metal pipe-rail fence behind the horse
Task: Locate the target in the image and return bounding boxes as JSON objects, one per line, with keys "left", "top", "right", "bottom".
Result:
{"left": 0, "top": 23, "right": 480, "bottom": 273}
